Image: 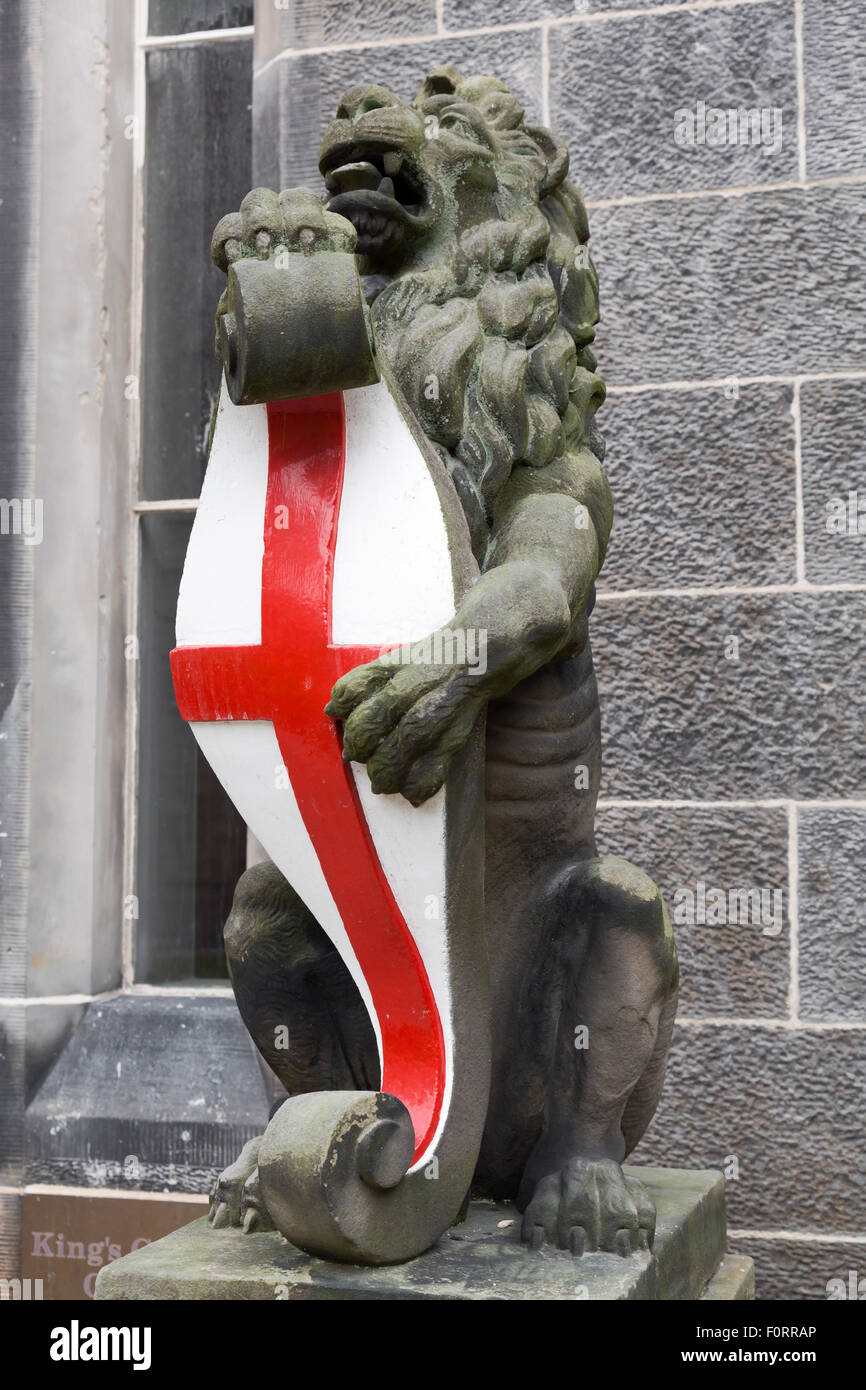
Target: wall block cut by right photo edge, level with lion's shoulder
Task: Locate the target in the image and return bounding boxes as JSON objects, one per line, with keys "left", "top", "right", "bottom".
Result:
{"left": 799, "top": 381, "right": 866, "bottom": 584}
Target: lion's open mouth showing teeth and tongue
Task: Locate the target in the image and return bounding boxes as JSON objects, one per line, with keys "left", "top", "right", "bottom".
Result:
{"left": 325, "top": 150, "right": 425, "bottom": 256}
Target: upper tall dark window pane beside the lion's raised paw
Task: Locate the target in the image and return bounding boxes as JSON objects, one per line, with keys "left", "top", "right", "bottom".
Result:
{"left": 142, "top": 40, "right": 252, "bottom": 498}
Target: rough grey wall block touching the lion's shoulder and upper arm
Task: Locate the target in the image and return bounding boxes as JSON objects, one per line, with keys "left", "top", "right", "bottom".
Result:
{"left": 598, "top": 383, "right": 795, "bottom": 592}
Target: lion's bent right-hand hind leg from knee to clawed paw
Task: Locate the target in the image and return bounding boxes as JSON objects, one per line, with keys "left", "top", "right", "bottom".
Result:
{"left": 518, "top": 856, "right": 677, "bottom": 1255}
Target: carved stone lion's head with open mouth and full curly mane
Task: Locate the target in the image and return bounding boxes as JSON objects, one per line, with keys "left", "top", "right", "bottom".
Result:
{"left": 320, "top": 67, "right": 603, "bottom": 563}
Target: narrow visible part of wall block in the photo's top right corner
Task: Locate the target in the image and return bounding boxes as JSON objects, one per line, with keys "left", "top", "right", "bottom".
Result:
{"left": 803, "top": 0, "right": 866, "bottom": 178}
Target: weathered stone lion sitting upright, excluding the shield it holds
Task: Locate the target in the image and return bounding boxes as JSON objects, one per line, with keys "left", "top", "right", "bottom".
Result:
{"left": 211, "top": 67, "right": 677, "bottom": 1255}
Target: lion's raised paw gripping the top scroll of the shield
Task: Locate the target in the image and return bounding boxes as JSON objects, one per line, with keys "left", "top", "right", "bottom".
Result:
{"left": 210, "top": 188, "right": 357, "bottom": 272}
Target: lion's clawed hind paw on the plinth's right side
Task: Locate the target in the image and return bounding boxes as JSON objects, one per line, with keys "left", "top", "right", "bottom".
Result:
{"left": 523, "top": 1158, "right": 656, "bottom": 1255}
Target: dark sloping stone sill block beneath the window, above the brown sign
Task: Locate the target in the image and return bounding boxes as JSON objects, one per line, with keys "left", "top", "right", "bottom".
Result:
{"left": 26, "top": 995, "right": 268, "bottom": 1193}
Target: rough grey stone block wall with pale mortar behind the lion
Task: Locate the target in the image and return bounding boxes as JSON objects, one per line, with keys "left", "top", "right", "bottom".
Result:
{"left": 253, "top": 0, "right": 866, "bottom": 1300}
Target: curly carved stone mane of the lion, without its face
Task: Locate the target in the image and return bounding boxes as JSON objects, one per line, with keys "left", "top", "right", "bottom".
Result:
{"left": 373, "top": 70, "right": 603, "bottom": 564}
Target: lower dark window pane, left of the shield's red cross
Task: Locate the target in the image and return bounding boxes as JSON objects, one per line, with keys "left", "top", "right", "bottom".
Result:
{"left": 135, "top": 514, "right": 246, "bottom": 984}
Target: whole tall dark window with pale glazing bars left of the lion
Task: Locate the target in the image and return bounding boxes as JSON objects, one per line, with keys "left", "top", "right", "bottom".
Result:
{"left": 134, "top": 32, "right": 252, "bottom": 984}
